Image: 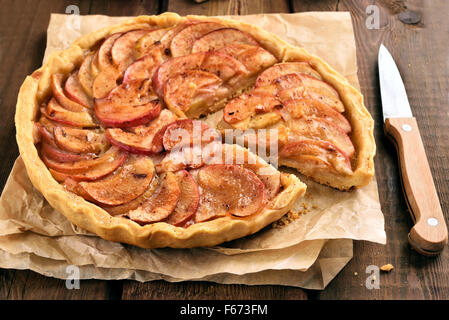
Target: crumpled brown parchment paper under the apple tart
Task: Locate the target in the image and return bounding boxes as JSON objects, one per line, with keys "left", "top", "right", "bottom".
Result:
{"left": 0, "top": 12, "right": 386, "bottom": 289}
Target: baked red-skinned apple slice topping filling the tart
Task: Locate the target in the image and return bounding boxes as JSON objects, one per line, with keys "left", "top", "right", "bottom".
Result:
{"left": 36, "top": 20, "right": 355, "bottom": 228}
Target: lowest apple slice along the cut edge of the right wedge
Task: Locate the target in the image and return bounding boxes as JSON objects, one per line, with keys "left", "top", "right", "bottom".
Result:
{"left": 279, "top": 139, "right": 353, "bottom": 177}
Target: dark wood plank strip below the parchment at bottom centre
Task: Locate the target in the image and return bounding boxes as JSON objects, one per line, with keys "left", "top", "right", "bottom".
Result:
{"left": 122, "top": 281, "right": 307, "bottom": 300}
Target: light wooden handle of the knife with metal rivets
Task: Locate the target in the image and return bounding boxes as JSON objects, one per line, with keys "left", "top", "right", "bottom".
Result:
{"left": 385, "top": 118, "right": 447, "bottom": 256}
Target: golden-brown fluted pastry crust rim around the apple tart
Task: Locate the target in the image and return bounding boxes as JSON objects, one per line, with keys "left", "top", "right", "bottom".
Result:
{"left": 15, "top": 13, "right": 375, "bottom": 248}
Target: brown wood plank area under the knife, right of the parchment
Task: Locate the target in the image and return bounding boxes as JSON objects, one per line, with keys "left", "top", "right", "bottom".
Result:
{"left": 288, "top": 0, "right": 449, "bottom": 299}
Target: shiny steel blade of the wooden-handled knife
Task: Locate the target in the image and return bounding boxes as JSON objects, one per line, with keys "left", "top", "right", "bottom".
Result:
{"left": 378, "top": 44, "right": 413, "bottom": 122}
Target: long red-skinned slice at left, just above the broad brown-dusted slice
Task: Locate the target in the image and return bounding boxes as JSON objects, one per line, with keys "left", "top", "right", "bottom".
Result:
{"left": 48, "top": 152, "right": 128, "bottom": 181}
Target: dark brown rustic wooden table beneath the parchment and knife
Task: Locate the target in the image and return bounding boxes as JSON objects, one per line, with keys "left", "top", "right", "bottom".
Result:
{"left": 0, "top": 0, "right": 449, "bottom": 300}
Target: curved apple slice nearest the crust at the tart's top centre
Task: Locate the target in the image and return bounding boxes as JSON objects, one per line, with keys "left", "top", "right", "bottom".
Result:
{"left": 170, "top": 22, "right": 223, "bottom": 57}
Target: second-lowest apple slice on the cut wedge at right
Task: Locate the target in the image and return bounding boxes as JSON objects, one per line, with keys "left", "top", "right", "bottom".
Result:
{"left": 287, "top": 118, "right": 355, "bottom": 158}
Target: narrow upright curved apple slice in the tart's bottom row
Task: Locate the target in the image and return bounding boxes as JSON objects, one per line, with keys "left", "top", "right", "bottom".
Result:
{"left": 166, "top": 170, "right": 200, "bottom": 226}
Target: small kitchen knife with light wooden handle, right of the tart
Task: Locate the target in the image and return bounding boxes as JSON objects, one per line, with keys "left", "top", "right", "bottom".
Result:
{"left": 378, "top": 45, "right": 448, "bottom": 256}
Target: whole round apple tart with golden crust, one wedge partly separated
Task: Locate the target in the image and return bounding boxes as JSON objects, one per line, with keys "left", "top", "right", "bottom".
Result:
{"left": 15, "top": 13, "right": 375, "bottom": 248}
